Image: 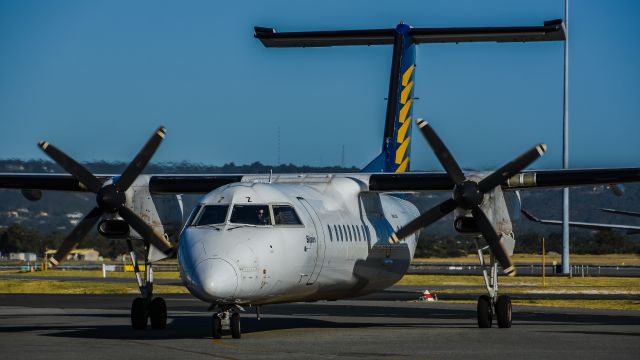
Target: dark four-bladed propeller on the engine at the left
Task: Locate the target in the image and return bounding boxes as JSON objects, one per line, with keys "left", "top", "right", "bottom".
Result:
{"left": 38, "top": 126, "right": 174, "bottom": 266}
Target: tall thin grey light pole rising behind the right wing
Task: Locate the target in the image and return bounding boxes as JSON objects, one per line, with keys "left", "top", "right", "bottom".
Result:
{"left": 562, "top": 0, "right": 570, "bottom": 275}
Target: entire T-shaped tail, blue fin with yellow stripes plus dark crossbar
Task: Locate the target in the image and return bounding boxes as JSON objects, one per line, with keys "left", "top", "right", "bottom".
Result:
{"left": 254, "top": 20, "right": 566, "bottom": 172}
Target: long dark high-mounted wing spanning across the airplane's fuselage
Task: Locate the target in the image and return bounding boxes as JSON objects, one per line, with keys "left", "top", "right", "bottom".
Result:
{"left": 0, "top": 168, "right": 640, "bottom": 194}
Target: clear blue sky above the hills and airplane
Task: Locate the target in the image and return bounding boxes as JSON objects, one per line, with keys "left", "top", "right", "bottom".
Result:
{"left": 0, "top": 0, "right": 640, "bottom": 169}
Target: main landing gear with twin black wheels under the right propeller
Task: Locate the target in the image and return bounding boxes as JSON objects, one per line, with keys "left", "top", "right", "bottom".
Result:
{"left": 475, "top": 239, "right": 512, "bottom": 328}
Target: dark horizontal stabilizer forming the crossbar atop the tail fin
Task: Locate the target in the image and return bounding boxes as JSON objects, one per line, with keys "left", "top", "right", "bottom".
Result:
{"left": 255, "top": 20, "right": 566, "bottom": 47}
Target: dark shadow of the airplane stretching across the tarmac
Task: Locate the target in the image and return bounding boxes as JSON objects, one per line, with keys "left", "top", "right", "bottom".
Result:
{"left": 0, "top": 296, "right": 640, "bottom": 340}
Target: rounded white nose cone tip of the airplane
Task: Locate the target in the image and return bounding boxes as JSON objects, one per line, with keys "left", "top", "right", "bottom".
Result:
{"left": 194, "top": 259, "right": 238, "bottom": 302}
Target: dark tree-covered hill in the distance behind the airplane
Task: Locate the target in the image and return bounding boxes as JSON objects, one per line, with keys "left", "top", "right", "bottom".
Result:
{"left": 0, "top": 159, "right": 640, "bottom": 255}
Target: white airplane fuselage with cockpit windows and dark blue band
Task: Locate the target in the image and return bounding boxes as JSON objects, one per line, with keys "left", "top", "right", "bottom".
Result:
{"left": 178, "top": 178, "right": 419, "bottom": 305}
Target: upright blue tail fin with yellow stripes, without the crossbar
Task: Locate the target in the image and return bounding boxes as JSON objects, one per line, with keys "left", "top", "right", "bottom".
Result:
{"left": 362, "top": 24, "right": 416, "bottom": 173}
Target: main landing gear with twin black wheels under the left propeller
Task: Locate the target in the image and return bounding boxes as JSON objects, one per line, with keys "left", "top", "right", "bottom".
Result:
{"left": 127, "top": 239, "right": 167, "bottom": 330}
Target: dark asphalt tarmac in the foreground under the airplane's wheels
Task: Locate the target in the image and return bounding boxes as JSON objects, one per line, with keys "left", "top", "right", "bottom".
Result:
{"left": 0, "top": 291, "right": 640, "bottom": 360}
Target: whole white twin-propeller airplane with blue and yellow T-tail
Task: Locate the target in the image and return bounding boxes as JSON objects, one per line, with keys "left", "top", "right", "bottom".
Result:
{"left": 0, "top": 20, "right": 640, "bottom": 338}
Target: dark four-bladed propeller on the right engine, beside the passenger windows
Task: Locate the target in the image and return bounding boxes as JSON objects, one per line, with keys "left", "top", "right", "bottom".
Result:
{"left": 389, "top": 119, "right": 547, "bottom": 276}
